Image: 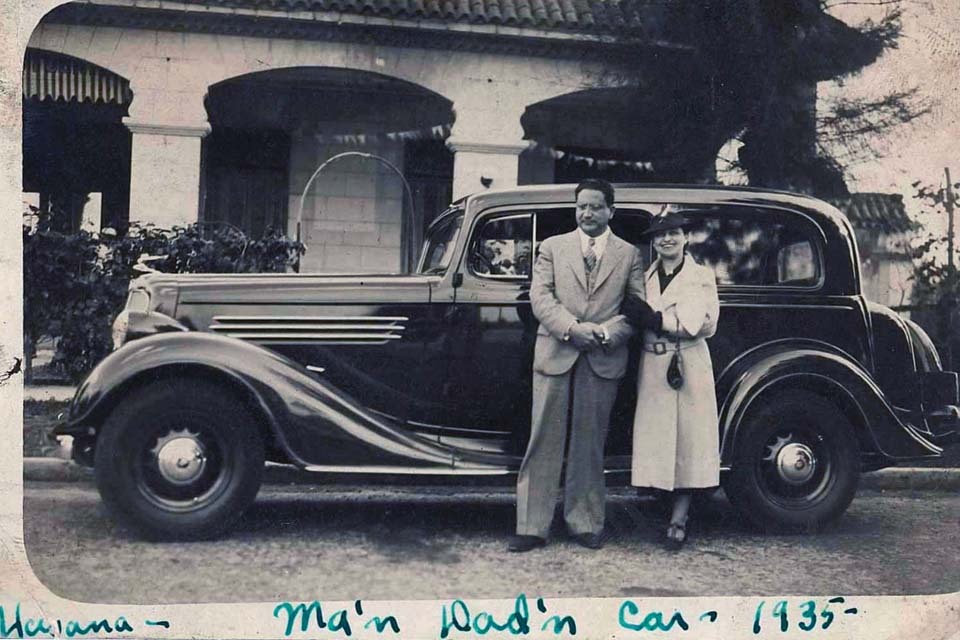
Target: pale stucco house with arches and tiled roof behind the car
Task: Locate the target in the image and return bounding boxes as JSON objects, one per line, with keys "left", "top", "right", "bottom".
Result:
{"left": 23, "top": 0, "right": 872, "bottom": 271}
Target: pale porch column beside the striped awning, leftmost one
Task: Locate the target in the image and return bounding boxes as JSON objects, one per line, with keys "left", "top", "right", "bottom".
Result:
{"left": 123, "top": 65, "right": 210, "bottom": 228}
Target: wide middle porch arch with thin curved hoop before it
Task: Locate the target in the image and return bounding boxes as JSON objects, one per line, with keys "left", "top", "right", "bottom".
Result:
{"left": 201, "top": 67, "right": 454, "bottom": 272}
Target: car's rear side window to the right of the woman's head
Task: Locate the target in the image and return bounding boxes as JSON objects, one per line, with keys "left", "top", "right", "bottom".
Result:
{"left": 685, "top": 207, "right": 821, "bottom": 287}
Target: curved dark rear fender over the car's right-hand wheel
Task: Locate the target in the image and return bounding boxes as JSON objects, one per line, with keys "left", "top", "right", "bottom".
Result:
{"left": 717, "top": 341, "right": 941, "bottom": 466}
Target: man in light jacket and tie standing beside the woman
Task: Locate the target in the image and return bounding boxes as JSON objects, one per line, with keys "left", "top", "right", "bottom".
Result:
{"left": 508, "top": 180, "right": 644, "bottom": 552}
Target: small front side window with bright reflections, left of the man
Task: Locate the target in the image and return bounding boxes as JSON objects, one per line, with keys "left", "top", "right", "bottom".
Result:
{"left": 467, "top": 213, "right": 533, "bottom": 278}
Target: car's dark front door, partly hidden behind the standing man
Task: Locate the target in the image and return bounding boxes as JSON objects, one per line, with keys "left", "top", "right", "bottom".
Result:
{"left": 443, "top": 204, "right": 650, "bottom": 465}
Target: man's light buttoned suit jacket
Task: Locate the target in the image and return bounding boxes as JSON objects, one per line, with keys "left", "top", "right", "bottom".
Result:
{"left": 530, "top": 231, "right": 644, "bottom": 379}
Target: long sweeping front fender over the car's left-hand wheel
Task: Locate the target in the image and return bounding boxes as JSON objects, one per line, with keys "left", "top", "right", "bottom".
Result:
{"left": 67, "top": 332, "right": 480, "bottom": 468}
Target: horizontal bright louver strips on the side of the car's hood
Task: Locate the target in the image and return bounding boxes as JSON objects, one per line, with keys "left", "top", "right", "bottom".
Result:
{"left": 210, "top": 316, "right": 408, "bottom": 345}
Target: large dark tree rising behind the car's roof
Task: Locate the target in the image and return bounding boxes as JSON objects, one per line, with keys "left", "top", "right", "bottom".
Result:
{"left": 623, "top": 0, "right": 929, "bottom": 197}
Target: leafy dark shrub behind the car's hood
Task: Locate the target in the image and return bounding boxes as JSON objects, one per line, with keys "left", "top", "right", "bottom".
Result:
{"left": 23, "top": 207, "right": 306, "bottom": 381}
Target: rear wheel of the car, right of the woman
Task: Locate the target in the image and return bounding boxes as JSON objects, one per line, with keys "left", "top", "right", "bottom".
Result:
{"left": 724, "top": 391, "right": 860, "bottom": 531}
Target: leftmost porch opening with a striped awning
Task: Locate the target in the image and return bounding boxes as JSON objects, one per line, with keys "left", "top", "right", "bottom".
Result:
{"left": 22, "top": 48, "right": 133, "bottom": 232}
